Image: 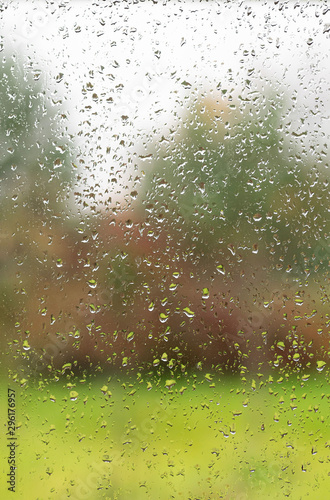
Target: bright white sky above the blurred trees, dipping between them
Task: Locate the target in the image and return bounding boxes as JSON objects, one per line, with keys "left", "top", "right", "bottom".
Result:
{"left": 1, "top": 0, "right": 330, "bottom": 209}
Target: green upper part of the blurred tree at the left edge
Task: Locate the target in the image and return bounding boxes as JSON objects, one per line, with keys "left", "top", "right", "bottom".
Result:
{"left": 0, "top": 55, "right": 72, "bottom": 215}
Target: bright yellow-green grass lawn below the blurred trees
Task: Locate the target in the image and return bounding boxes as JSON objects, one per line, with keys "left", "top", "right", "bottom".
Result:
{"left": 0, "top": 373, "right": 330, "bottom": 500}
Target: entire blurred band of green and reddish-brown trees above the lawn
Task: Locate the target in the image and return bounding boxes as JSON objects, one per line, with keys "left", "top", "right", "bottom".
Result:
{"left": 0, "top": 52, "right": 329, "bottom": 377}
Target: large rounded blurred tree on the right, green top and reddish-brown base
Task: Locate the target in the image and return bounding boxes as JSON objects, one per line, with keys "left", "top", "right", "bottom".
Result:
{"left": 100, "top": 88, "right": 330, "bottom": 372}
